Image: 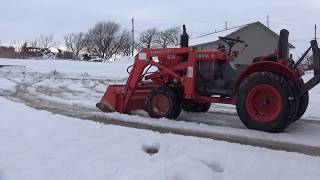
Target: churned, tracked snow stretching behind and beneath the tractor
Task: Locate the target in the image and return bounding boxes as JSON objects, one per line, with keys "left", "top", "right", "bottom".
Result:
{"left": 0, "top": 60, "right": 320, "bottom": 147}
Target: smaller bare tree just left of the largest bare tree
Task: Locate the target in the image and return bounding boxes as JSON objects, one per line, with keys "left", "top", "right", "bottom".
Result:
{"left": 64, "top": 32, "right": 87, "bottom": 59}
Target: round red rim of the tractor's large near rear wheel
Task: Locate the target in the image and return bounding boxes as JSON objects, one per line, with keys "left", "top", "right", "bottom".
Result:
{"left": 246, "top": 84, "right": 282, "bottom": 122}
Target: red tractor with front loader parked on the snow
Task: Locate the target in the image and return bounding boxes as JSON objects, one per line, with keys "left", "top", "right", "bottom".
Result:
{"left": 97, "top": 26, "right": 320, "bottom": 133}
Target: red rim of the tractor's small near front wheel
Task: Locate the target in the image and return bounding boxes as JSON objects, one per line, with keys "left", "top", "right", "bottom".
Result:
{"left": 152, "top": 94, "right": 170, "bottom": 116}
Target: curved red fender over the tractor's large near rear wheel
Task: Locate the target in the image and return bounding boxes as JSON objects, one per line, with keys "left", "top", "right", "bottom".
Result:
{"left": 233, "top": 61, "right": 300, "bottom": 93}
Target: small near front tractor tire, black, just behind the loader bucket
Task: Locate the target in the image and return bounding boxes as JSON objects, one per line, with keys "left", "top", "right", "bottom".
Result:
{"left": 146, "top": 86, "right": 181, "bottom": 119}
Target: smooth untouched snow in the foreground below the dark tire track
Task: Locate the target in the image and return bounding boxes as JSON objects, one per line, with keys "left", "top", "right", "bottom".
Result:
{"left": 0, "top": 97, "right": 320, "bottom": 180}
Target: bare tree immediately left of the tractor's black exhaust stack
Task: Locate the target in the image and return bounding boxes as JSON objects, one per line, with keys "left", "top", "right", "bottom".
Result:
{"left": 155, "top": 27, "right": 180, "bottom": 48}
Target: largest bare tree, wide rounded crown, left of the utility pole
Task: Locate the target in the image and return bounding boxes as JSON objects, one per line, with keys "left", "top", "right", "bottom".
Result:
{"left": 86, "top": 22, "right": 126, "bottom": 59}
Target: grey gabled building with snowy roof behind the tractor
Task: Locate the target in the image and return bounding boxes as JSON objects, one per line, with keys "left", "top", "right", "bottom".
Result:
{"left": 189, "top": 22, "right": 294, "bottom": 69}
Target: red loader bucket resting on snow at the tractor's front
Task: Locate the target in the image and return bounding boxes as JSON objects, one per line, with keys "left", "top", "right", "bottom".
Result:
{"left": 96, "top": 85, "right": 125, "bottom": 112}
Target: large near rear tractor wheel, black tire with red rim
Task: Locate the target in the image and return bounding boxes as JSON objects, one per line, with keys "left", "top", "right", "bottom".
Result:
{"left": 236, "top": 72, "right": 297, "bottom": 133}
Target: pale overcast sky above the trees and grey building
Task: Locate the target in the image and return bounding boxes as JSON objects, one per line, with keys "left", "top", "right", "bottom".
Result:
{"left": 0, "top": 0, "right": 320, "bottom": 52}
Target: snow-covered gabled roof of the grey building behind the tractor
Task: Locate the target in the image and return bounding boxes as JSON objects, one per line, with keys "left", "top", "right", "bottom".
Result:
{"left": 189, "top": 21, "right": 295, "bottom": 48}
